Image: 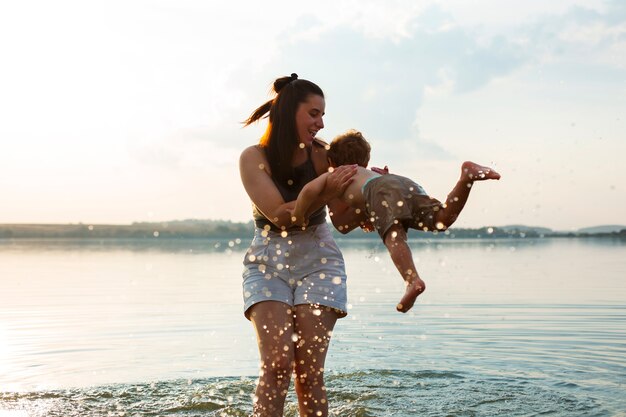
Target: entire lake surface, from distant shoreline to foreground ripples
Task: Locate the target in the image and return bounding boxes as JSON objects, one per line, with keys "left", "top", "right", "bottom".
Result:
{"left": 0, "top": 239, "right": 626, "bottom": 417}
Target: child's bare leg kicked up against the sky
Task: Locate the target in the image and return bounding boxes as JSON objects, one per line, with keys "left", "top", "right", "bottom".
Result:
{"left": 434, "top": 161, "right": 500, "bottom": 230}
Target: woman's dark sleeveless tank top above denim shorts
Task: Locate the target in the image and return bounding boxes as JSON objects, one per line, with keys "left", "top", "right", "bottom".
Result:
{"left": 252, "top": 145, "right": 326, "bottom": 232}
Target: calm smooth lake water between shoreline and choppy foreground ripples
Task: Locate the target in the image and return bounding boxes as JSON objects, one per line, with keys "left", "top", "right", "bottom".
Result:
{"left": 0, "top": 239, "right": 626, "bottom": 391}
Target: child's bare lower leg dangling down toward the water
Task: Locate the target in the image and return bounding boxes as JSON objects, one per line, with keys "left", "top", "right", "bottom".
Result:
{"left": 384, "top": 225, "right": 426, "bottom": 313}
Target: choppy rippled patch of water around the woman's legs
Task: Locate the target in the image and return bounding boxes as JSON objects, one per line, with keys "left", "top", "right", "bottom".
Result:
{"left": 0, "top": 370, "right": 614, "bottom": 417}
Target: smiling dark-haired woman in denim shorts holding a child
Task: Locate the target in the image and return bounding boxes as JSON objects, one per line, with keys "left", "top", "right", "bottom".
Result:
{"left": 239, "top": 74, "right": 358, "bottom": 417}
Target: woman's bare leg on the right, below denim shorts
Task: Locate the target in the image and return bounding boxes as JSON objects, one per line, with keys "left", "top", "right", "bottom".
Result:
{"left": 294, "top": 304, "right": 337, "bottom": 417}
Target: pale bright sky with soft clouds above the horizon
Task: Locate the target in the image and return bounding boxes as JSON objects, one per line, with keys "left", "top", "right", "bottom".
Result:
{"left": 0, "top": 0, "right": 626, "bottom": 230}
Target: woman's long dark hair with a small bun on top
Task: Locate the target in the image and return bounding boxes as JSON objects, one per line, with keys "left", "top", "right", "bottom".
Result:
{"left": 243, "top": 74, "right": 324, "bottom": 183}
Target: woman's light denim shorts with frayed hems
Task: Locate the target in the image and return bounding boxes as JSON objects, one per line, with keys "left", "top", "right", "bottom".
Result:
{"left": 243, "top": 223, "right": 347, "bottom": 319}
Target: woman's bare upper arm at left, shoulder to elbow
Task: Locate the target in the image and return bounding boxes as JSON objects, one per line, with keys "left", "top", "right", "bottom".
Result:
{"left": 239, "top": 146, "right": 295, "bottom": 229}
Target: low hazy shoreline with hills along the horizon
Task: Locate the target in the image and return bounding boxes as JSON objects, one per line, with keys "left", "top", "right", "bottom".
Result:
{"left": 0, "top": 220, "right": 626, "bottom": 241}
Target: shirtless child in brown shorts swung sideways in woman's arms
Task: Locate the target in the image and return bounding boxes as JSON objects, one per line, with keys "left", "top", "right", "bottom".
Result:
{"left": 292, "top": 130, "right": 500, "bottom": 313}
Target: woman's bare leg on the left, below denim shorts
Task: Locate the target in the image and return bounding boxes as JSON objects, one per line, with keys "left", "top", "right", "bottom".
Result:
{"left": 250, "top": 301, "right": 294, "bottom": 417}
